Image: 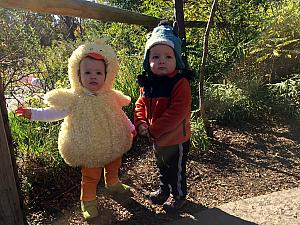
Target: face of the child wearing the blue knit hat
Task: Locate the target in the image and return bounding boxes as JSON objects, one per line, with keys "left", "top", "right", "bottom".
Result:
{"left": 149, "top": 44, "right": 176, "bottom": 76}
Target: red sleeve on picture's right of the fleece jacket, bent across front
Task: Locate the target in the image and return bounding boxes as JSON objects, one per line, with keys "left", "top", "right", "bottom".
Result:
{"left": 149, "top": 79, "right": 192, "bottom": 138}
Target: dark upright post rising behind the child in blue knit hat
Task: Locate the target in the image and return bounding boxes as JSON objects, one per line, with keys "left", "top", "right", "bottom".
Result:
{"left": 174, "top": 0, "right": 187, "bottom": 66}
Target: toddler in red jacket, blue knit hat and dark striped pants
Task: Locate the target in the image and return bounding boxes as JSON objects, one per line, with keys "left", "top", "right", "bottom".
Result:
{"left": 134, "top": 22, "right": 192, "bottom": 212}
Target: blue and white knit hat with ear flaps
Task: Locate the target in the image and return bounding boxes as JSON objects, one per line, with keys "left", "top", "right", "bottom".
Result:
{"left": 143, "top": 22, "right": 185, "bottom": 71}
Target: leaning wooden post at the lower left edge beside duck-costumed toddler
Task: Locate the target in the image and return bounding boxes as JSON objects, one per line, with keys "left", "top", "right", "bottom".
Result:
{"left": 0, "top": 97, "right": 25, "bottom": 225}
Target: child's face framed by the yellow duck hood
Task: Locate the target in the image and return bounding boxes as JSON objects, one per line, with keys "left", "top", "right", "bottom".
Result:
{"left": 80, "top": 57, "right": 105, "bottom": 93}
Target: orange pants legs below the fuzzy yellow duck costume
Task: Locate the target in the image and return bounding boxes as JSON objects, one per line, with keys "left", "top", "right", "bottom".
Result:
{"left": 80, "top": 158, "right": 121, "bottom": 201}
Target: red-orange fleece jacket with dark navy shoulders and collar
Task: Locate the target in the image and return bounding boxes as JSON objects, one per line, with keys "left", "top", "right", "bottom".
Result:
{"left": 134, "top": 71, "right": 192, "bottom": 146}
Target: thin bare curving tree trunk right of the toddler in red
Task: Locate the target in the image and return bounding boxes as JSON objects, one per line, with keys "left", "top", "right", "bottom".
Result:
{"left": 198, "top": 0, "right": 218, "bottom": 137}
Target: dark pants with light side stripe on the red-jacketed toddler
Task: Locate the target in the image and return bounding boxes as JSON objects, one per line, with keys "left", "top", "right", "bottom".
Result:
{"left": 153, "top": 141, "right": 190, "bottom": 197}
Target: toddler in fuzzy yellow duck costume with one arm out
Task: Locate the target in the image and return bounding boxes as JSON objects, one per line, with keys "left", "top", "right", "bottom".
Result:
{"left": 16, "top": 39, "right": 135, "bottom": 219}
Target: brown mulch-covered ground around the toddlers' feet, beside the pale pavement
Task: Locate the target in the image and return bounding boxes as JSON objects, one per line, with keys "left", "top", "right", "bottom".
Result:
{"left": 26, "top": 118, "right": 300, "bottom": 225}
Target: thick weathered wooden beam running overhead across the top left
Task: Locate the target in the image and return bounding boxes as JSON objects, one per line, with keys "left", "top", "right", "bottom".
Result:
{"left": 0, "top": 0, "right": 160, "bottom": 27}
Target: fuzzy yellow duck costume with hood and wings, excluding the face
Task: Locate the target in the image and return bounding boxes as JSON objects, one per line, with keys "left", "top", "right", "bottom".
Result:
{"left": 45, "top": 39, "right": 132, "bottom": 167}
